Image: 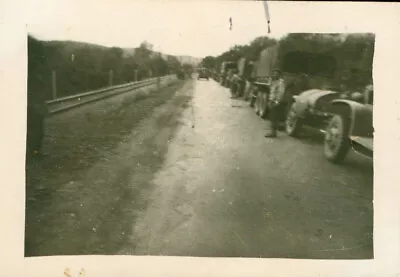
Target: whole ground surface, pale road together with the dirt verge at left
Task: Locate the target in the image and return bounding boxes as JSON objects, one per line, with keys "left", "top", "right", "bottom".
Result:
{"left": 26, "top": 77, "right": 373, "bottom": 259}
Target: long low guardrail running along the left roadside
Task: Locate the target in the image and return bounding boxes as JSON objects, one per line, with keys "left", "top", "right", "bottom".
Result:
{"left": 46, "top": 75, "right": 174, "bottom": 115}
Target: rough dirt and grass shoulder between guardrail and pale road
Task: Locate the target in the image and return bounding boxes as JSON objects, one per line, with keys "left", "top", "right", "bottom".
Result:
{"left": 25, "top": 80, "right": 193, "bottom": 256}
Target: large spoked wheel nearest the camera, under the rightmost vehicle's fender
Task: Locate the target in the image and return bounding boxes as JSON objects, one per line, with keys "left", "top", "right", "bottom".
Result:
{"left": 324, "top": 115, "right": 350, "bottom": 163}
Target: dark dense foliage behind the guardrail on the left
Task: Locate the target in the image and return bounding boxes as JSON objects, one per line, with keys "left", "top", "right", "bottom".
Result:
{"left": 28, "top": 36, "right": 189, "bottom": 99}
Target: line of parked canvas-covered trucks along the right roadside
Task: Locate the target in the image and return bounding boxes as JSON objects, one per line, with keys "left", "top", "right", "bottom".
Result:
{"left": 212, "top": 35, "right": 373, "bottom": 163}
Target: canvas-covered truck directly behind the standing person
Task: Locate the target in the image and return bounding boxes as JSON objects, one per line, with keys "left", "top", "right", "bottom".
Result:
{"left": 250, "top": 43, "right": 337, "bottom": 121}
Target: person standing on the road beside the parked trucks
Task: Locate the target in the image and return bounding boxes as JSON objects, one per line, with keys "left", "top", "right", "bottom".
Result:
{"left": 265, "top": 69, "right": 285, "bottom": 138}
